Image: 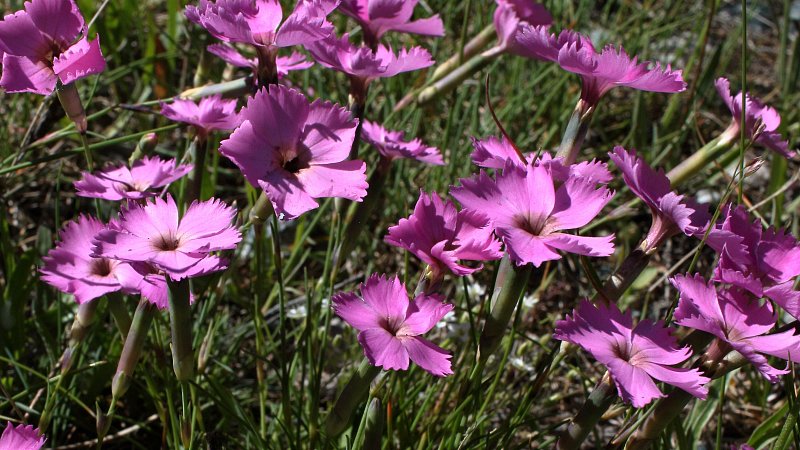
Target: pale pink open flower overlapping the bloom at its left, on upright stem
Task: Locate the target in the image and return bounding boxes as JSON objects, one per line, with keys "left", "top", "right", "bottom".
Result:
{"left": 94, "top": 195, "right": 242, "bottom": 280}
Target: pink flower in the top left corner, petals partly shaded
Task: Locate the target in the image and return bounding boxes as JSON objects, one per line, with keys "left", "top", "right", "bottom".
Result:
{"left": 0, "top": 0, "right": 106, "bottom": 95}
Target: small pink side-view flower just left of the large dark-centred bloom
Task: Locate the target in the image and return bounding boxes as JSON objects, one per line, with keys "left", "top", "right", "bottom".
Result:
{"left": 161, "top": 94, "right": 242, "bottom": 135}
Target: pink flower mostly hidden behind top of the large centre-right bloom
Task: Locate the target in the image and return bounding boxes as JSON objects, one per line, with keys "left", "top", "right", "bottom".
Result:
{"left": 471, "top": 136, "right": 614, "bottom": 184}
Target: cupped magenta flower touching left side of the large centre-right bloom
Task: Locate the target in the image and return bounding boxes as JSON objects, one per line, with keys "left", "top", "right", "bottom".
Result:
{"left": 385, "top": 191, "right": 503, "bottom": 276}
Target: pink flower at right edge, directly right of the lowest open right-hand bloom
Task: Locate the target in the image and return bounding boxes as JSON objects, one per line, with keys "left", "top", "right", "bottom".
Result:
{"left": 671, "top": 275, "right": 800, "bottom": 383}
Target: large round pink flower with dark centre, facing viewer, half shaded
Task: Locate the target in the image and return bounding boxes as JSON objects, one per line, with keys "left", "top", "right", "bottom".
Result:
{"left": 219, "top": 86, "right": 367, "bottom": 219}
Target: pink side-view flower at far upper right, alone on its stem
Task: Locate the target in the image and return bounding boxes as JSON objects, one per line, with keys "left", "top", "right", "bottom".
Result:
{"left": 714, "top": 78, "right": 795, "bottom": 158}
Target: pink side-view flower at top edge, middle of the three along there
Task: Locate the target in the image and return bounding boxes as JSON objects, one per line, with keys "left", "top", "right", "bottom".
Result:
{"left": 339, "top": 0, "right": 444, "bottom": 48}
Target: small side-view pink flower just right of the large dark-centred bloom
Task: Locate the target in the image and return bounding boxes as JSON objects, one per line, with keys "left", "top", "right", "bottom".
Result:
{"left": 361, "top": 120, "right": 444, "bottom": 166}
